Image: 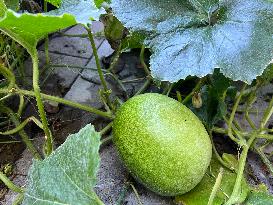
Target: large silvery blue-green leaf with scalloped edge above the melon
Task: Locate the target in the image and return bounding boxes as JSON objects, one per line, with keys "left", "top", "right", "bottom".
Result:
{"left": 112, "top": 0, "right": 273, "bottom": 83}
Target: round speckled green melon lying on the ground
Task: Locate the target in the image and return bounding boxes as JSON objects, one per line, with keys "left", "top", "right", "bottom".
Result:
{"left": 113, "top": 93, "right": 212, "bottom": 196}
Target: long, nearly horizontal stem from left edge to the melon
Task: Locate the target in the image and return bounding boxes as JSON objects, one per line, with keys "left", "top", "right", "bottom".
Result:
{"left": 0, "top": 89, "right": 114, "bottom": 119}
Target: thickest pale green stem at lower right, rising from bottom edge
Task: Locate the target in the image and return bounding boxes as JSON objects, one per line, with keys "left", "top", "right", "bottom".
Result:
{"left": 225, "top": 133, "right": 256, "bottom": 205}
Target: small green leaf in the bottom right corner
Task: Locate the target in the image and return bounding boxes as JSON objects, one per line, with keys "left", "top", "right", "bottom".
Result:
{"left": 245, "top": 190, "right": 273, "bottom": 205}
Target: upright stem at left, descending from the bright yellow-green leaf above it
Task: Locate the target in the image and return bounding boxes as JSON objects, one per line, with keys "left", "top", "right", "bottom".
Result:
{"left": 31, "top": 51, "right": 53, "bottom": 156}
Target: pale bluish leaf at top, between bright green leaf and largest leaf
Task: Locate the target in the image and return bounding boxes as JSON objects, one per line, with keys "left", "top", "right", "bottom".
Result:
{"left": 47, "top": 0, "right": 105, "bottom": 24}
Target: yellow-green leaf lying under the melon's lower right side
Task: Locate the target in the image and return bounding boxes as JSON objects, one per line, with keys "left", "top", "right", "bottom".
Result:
{"left": 175, "top": 156, "right": 249, "bottom": 205}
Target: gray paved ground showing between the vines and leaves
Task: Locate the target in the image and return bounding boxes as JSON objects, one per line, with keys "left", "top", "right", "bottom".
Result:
{"left": 0, "top": 23, "right": 273, "bottom": 205}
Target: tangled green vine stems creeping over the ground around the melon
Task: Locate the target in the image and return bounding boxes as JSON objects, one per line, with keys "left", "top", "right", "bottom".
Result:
{"left": 0, "top": 18, "right": 273, "bottom": 205}
